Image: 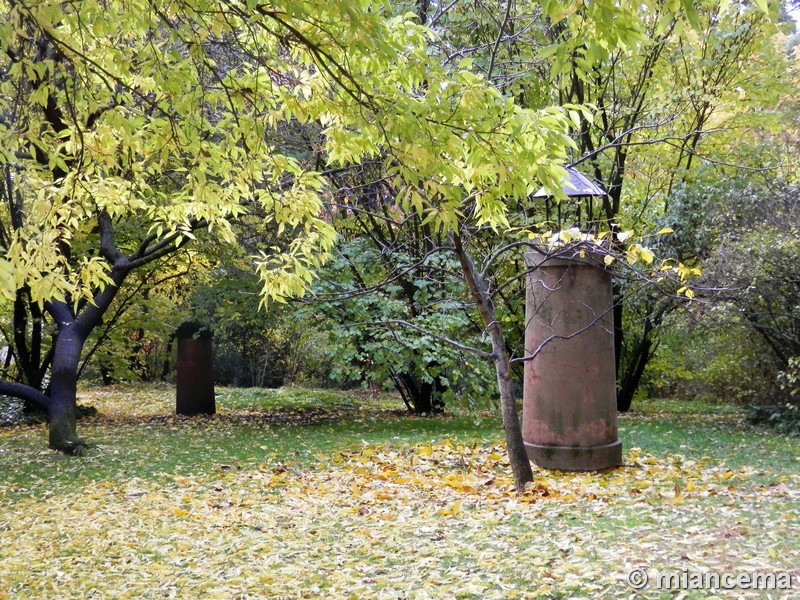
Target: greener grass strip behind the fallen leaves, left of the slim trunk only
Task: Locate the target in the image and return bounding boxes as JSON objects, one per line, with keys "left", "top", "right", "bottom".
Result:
{"left": 0, "top": 386, "right": 500, "bottom": 495}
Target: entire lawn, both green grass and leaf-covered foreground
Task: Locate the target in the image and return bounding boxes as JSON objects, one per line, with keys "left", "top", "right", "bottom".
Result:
{"left": 0, "top": 387, "right": 800, "bottom": 599}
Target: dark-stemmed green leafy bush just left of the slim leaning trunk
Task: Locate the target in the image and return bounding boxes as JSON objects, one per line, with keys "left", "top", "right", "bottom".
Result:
{"left": 302, "top": 237, "right": 494, "bottom": 414}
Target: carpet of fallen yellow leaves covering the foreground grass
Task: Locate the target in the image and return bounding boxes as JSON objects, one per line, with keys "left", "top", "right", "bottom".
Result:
{"left": 0, "top": 386, "right": 800, "bottom": 599}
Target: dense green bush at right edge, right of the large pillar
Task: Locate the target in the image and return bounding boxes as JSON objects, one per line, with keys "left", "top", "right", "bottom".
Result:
{"left": 647, "top": 177, "right": 800, "bottom": 405}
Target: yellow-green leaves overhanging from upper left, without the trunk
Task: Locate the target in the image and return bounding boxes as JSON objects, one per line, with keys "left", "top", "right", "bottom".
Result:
{"left": 0, "top": 0, "right": 588, "bottom": 300}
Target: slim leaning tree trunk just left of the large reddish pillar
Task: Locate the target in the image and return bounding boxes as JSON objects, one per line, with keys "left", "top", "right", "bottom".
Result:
{"left": 453, "top": 234, "right": 533, "bottom": 494}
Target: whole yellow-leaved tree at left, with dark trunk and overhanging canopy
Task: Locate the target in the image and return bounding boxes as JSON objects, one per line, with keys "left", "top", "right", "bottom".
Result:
{"left": 0, "top": 0, "right": 571, "bottom": 460}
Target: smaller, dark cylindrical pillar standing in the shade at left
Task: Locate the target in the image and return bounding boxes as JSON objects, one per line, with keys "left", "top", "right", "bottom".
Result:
{"left": 175, "top": 322, "right": 217, "bottom": 416}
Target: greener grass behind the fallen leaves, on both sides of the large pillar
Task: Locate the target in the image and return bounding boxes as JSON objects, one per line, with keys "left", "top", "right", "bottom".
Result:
{"left": 0, "top": 386, "right": 800, "bottom": 495}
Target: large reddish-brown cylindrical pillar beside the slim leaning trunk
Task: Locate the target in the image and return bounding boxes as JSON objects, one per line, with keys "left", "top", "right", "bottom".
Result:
{"left": 522, "top": 246, "right": 622, "bottom": 471}
